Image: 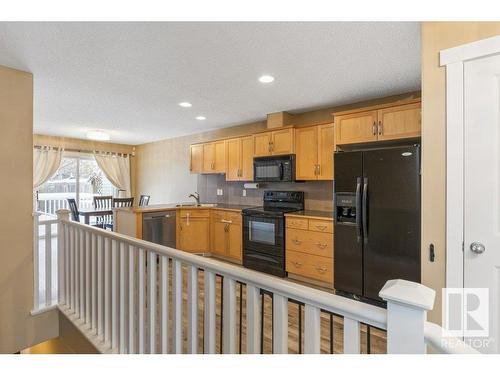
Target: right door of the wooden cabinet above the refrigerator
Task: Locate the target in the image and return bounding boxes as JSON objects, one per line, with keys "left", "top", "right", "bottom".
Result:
{"left": 378, "top": 103, "right": 421, "bottom": 140}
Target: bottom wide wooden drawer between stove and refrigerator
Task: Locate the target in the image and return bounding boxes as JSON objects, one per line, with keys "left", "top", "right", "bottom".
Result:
{"left": 286, "top": 250, "right": 333, "bottom": 283}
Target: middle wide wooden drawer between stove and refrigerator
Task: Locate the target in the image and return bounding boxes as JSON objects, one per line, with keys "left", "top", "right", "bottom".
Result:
{"left": 286, "top": 228, "right": 333, "bottom": 258}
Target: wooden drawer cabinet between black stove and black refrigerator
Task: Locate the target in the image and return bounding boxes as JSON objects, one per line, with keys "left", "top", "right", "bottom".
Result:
{"left": 285, "top": 216, "right": 334, "bottom": 287}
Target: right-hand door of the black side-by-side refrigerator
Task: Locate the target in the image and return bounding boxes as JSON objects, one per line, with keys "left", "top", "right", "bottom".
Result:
{"left": 362, "top": 146, "right": 420, "bottom": 300}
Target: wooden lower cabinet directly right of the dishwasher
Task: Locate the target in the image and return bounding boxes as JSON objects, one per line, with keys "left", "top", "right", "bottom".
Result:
{"left": 176, "top": 210, "right": 210, "bottom": 253}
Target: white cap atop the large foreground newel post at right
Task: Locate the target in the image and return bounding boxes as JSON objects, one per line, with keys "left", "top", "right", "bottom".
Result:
{"left": 379, "top": 279, "right": 436, "bottom": 310}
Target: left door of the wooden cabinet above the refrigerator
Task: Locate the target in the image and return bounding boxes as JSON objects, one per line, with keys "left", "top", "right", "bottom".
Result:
{"left": 335, "top": 111, "right": 377, "bottom": 145}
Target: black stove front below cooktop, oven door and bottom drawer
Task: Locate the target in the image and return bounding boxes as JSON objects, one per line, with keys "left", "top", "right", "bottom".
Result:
{"left": 243, "top": 214, "right": 285, "bottom": 277}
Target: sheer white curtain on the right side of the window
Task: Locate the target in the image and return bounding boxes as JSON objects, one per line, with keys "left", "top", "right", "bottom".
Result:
{"left": 94, "top": 153, "right": 132, "bottom": 197}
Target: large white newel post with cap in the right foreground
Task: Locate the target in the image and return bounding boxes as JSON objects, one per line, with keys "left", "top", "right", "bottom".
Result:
{"left": 379, "top": 280, "right": 436, "bottom": 354}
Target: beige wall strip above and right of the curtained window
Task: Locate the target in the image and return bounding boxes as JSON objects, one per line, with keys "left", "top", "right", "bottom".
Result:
{"left": 33, "top": 134, "right": 137, "bottom": 200}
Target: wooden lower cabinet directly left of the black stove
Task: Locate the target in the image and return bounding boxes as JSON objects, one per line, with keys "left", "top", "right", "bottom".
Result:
{"left": 210, "top": 210, "right": 242, "bottom": 263}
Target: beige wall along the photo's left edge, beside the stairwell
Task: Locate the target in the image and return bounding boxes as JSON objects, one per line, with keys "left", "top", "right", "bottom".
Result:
{"left": 0, "top": 66, "right": 58, "bottom": 353}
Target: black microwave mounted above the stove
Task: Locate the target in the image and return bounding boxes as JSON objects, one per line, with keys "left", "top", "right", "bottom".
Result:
{"left": 253, "top": 154, "right": 295, "bottom": 182}
